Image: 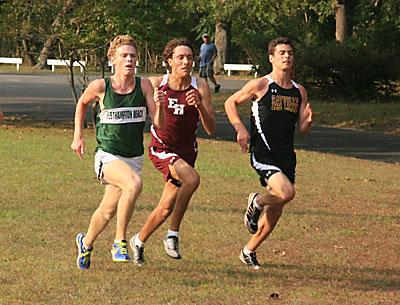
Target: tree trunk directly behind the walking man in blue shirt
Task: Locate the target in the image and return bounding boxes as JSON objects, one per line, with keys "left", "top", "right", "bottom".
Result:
{"left": 214, "top": 22, "right": 230, "bottom": 74}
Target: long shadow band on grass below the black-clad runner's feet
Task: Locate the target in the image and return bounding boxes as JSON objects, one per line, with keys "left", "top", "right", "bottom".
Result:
{"left": 157, "top": 259, "right": 400, "bottom": 292}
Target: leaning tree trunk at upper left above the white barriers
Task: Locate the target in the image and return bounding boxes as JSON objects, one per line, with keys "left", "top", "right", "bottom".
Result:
{"left": 35, "top": 0, "right": 75, "bottom": 70}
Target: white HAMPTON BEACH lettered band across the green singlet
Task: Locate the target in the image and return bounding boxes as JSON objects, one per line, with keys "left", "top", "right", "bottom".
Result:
{"left": 99, "top": 106, "right": 146, "bottom": 124}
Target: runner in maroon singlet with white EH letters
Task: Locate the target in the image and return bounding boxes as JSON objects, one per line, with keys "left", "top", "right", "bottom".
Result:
{"left": 130, "top": 39, "right": 215, "bottom": 266}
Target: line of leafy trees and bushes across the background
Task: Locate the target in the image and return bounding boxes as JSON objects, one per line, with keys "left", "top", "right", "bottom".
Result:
{"left": 0, "top": 0, "right": 400, "bottom": 96}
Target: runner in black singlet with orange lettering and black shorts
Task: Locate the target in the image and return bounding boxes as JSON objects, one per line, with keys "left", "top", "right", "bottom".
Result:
{"left": 225, "top": 37, "right": 313, "bottom": 269}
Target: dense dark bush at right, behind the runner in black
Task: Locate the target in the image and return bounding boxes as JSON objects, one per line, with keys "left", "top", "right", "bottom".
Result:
{"left": 296, "top": 41, "right": 400, "bottom": 96}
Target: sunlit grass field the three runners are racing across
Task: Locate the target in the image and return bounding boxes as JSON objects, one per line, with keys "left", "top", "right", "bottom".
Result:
{"left": 0, "top": 125, "right": 400, "bottom": 305}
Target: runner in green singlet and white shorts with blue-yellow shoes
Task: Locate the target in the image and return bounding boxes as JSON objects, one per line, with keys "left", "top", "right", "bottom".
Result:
{"left": 71, "top": 35, "right": 164, "bottom": 270}
